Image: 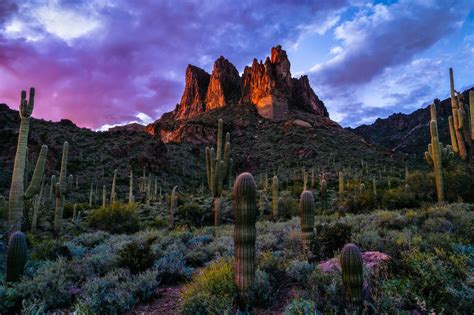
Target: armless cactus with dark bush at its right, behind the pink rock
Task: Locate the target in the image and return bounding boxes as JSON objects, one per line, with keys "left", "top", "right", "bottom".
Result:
{"left": 300, "top": 190, "right": 314, "bottom": 256}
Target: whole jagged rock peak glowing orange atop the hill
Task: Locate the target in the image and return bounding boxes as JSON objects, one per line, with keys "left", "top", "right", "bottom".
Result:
{"left": 169, "top": 46, "right": 329, "bottom": 120}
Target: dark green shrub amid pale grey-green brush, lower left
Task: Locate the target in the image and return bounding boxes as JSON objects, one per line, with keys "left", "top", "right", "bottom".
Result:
{"left": 118, "top": 238, "right": 156, "bottom": 274}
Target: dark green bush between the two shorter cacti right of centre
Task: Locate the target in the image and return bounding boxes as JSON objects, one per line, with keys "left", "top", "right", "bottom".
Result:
{"left": 315, "top": 222, "right": 352, "bottom": 258}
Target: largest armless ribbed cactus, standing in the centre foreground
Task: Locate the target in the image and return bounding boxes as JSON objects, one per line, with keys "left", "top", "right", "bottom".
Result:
{"left": 233, "top": 173, "right": 257, "bottom": 305}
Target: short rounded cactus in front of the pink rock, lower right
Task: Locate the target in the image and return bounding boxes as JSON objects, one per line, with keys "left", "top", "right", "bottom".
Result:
{"left": 341, "top": 243, "right": 364, "bottom": 304}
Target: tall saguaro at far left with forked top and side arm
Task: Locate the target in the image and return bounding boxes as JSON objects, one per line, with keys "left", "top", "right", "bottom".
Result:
{"left": 8, "top": 88, "right": 48, "bottom": 232}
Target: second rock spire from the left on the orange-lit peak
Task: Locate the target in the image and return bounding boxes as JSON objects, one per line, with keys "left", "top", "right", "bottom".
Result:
{"left": 206, "top": 56, "right": 240, "bottom": 110}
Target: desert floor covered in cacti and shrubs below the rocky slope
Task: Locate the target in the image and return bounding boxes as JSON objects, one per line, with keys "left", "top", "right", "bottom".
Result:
{"left": 0, "top": 65, "right": 474, "bottom": 314}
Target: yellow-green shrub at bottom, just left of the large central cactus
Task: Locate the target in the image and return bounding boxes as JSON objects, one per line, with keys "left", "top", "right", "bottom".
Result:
{"left": 181, "top": 259, "right": 237, "bottom": 314}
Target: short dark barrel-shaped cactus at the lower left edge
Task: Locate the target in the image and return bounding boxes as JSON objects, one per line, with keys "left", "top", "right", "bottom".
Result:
{"left": 6, "top": 231, "right": 27, "bottom": 282}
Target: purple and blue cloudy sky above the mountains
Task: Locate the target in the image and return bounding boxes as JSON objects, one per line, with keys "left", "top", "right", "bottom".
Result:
{"left": 0, "top": 0, "right": 474, "bottom": 130}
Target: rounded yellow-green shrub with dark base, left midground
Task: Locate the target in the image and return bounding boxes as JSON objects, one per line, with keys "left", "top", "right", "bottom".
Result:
{"left": 89, "top": 203, "right": 139, "bottom": 233}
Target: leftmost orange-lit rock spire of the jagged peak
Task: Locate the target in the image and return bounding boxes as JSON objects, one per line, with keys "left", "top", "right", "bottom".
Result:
{"left": 173, "top": 65, "right": 210, "bottom": 119}
